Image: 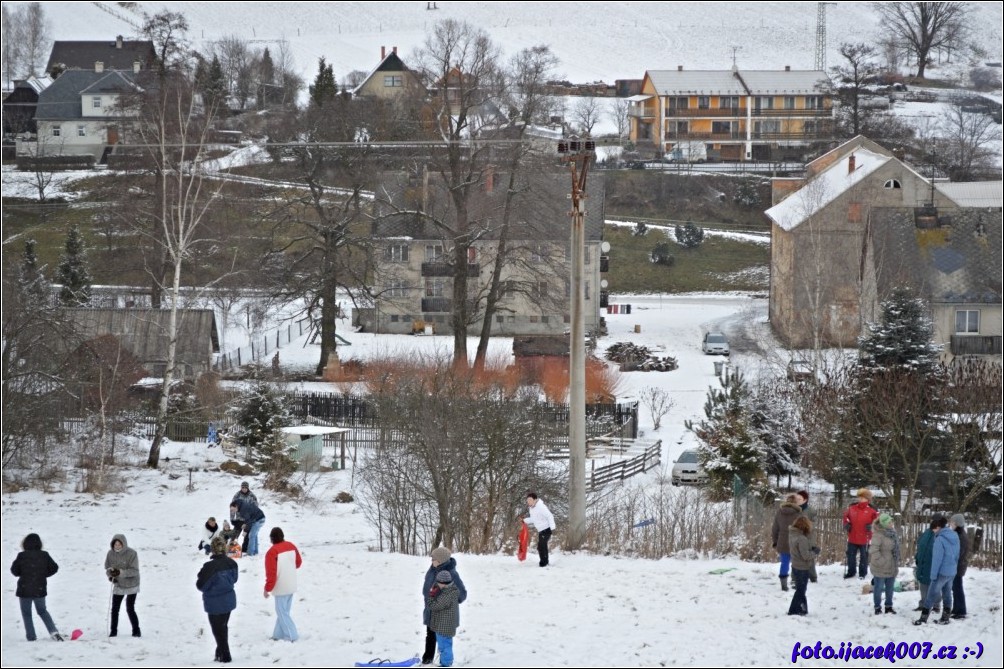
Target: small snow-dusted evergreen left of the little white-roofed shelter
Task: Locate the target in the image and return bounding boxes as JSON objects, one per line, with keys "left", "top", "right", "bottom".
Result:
{"left": 230, "top": 379, "right": 296, "bottom": 488}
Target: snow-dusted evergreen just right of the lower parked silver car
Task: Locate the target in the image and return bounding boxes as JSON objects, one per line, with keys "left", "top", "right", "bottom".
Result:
{"left": 686, "top": 372, "right": 765, "bottom": 499}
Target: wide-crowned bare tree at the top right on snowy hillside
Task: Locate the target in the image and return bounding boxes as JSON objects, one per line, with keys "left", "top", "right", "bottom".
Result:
{"left": 872, "top": 2, "right": 970, "bottom": 79}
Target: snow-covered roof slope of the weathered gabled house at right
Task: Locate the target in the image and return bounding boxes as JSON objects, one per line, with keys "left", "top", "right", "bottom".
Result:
{"left": 765, "top": 149, "right": 893, "bottom": 230}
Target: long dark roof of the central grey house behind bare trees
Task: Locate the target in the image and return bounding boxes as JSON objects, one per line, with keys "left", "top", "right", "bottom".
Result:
{"left": 372, "top": 171, "right": 603, "bottom": 240}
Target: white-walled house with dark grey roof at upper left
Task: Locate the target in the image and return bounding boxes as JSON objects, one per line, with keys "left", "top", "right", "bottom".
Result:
{"left": 30, "top": 63, "right": 142, "bottom": 163}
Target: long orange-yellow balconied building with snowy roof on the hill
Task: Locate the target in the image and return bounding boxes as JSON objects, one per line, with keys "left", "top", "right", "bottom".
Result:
{"left": 628, "top": 66, "right": 833, "bottom": 162}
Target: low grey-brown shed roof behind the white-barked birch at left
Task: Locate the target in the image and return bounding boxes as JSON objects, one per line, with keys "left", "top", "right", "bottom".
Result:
{"left": 65, "top": 308, "right": 220, "bottom": 368}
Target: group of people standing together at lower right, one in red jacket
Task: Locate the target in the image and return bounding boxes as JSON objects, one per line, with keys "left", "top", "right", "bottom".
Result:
{"left": 771, "top": 488, "right": 970, "bottom": 625}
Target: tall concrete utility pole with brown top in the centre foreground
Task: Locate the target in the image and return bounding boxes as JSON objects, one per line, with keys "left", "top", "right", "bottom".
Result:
{"left": 558, "top": 140, "right": 596, "bottom": 550}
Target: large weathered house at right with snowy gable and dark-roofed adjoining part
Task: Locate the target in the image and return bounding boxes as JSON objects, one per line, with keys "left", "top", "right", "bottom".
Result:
{"left": 766, "top": 132, "right": 1001, "bottom": 352}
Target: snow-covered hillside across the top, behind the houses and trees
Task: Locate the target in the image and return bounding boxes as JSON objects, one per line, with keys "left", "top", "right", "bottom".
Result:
{"left": 31, "top": 0, "right": 1004, "bottom": 83}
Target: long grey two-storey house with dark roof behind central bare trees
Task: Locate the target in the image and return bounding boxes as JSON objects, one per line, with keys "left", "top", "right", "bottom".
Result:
{"left": 358, "top": 166, "right": 606, "bottom": 336}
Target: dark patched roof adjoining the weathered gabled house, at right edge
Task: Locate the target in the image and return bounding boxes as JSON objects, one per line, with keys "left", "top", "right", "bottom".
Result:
{"left": 870, "top": 208, "right": 1002, "bottom": 304}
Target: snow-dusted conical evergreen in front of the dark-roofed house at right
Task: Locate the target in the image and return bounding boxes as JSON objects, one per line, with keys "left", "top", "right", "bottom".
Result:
{"left": 858, "top": 287, "right": 940, "bottom": 374}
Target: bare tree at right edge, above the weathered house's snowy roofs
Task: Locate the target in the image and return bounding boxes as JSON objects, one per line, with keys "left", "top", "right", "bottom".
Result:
{"left": 937, "top": 100, "right": 1001, "bottom": 181}
